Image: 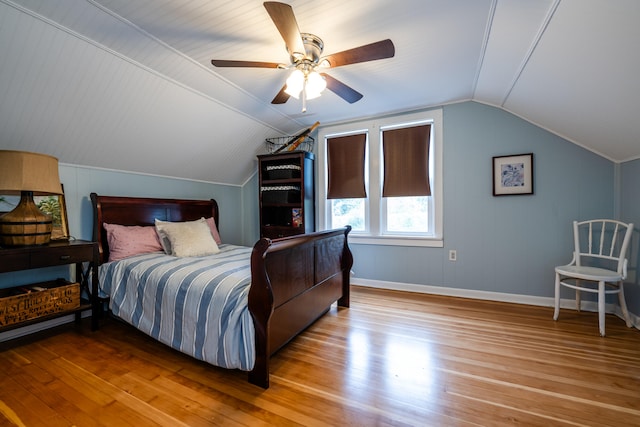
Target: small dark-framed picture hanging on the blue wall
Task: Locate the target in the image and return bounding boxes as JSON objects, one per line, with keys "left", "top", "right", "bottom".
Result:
{"left": 493, "top": 153, "right": 533, "bottom": 196}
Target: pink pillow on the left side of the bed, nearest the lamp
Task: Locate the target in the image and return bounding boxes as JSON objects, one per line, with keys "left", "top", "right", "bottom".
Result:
{"left": 103, "top": 223, "right": 162, "bottom": 261}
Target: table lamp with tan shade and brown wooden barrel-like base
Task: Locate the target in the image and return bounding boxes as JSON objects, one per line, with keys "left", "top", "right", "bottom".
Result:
{"left": 0, "top": 150, "right": 62, "bottom": 247}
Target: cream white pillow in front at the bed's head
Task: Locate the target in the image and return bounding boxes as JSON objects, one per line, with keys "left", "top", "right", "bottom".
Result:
{"left": 155, "top": 218, "right": 220, "bottom": 257}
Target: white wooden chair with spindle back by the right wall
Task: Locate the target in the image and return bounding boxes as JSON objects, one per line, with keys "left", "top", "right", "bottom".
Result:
{"left": 553, "top": 219, "right": 633, "bottom": 336}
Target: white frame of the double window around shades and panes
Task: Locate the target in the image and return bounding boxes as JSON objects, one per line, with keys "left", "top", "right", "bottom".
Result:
{"left": 317, "top": 109, "right": 444, "bottom": 247}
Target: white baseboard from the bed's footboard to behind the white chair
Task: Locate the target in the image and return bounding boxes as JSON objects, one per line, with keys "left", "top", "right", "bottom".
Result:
{"left": 351, "top": 276, "right": 640, "bottom": 329}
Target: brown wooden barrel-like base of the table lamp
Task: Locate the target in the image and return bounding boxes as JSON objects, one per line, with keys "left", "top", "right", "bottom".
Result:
{"left": 0, "top": 191, "right": 53, "bottom": 247}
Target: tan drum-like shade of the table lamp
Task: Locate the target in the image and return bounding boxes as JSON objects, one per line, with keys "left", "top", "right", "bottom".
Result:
{"left": 0, "top": 150, "right": 62, "bottom": 196}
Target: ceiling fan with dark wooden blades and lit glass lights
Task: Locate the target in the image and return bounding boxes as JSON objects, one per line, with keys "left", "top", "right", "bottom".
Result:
{"left": 211, "top": 1, "right": 395, "bottom": 112}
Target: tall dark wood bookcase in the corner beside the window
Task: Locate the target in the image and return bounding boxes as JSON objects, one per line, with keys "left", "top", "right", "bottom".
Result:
{"left": 258, "top": 151, "right": 316, "bottom": 239}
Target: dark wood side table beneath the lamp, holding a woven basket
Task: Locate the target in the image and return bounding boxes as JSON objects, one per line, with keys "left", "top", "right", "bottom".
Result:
{"left": 0, "top": 240, "right": 99, "bottom": 332}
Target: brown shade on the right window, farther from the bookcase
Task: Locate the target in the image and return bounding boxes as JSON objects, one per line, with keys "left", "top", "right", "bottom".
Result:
{"left": 382, "top": 125, "right": 431, "bottom": 197}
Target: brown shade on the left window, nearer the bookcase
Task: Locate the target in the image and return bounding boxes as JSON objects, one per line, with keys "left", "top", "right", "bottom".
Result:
{"left": 327, "top": 133, "right": 367, "bottom": 199}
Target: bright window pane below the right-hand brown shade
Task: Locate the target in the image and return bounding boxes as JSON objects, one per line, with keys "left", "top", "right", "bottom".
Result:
{"left": 387, "top": 196, "right": 429, "bottom": 233}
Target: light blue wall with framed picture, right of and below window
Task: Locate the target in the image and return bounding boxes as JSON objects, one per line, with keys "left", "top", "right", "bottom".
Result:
{"left": 352, "top": 102, "right": 615, "bottom": 297}
